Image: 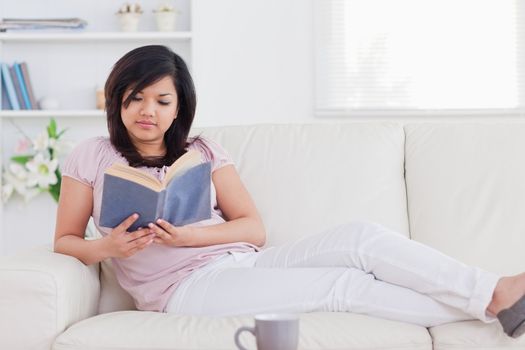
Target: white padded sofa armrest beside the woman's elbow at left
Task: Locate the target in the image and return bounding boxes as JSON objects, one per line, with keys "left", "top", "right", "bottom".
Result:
{"left": 0, "top": 247, "right": 100, "bottom": 350}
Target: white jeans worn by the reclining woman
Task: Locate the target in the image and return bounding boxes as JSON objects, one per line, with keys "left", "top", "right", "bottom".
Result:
{"left": 166, "top": 222, "right": 499, "bottom": 327}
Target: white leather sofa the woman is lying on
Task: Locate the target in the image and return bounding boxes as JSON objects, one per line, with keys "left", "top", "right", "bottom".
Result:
{"left": 0, "top": 121, "right": 525, "bottom": 350}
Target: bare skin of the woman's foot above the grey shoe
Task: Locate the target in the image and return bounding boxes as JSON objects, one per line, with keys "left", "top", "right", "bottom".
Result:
{"left": 487, "top": 272, "right": 525, "bottom": 315}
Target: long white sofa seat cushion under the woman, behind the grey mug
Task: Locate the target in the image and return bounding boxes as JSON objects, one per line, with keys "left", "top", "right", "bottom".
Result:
{"left": 53, "top": 311, "right": 432, "bottom": 350}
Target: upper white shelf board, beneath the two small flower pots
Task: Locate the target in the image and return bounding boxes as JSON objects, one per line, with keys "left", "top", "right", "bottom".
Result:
{"left": 0, "top": 32, "right": 192, "bottom": 42}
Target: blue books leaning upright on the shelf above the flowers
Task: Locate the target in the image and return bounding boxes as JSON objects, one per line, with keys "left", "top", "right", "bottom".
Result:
{"left": 0, "top": 62, "right": 39, "bottom": 110}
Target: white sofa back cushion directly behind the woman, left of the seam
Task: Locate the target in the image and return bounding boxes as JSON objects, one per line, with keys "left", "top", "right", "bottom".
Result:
{"left": 193, "top": 122, "right": 408, "bottom": 245}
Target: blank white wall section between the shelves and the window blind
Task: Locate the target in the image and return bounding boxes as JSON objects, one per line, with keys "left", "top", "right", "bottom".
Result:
{"left": 192, "top": 0, "right": 314, "bottom": 125}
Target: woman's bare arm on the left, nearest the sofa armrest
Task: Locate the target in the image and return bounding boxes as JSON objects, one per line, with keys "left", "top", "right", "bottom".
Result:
{"left": 54, "top": 176, "right": 153, "bottom": 265}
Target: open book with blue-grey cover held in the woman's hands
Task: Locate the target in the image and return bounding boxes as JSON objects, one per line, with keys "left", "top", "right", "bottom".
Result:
{"left": 99, "top": 150, "right": 211, "bottom": 232}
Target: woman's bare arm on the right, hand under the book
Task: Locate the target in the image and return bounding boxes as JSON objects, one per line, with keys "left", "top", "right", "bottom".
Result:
{"left": 150, "top": 165, "right": 266, "bottom": 247}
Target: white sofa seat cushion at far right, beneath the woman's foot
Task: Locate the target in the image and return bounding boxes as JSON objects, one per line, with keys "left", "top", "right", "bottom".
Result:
{"left": 430, "top": 321, "right": 525, "bottom": 350}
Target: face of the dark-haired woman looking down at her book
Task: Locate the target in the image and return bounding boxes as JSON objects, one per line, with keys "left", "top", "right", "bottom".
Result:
{"left": 120, "top": 76, "right": 178, "bottom": 150}
